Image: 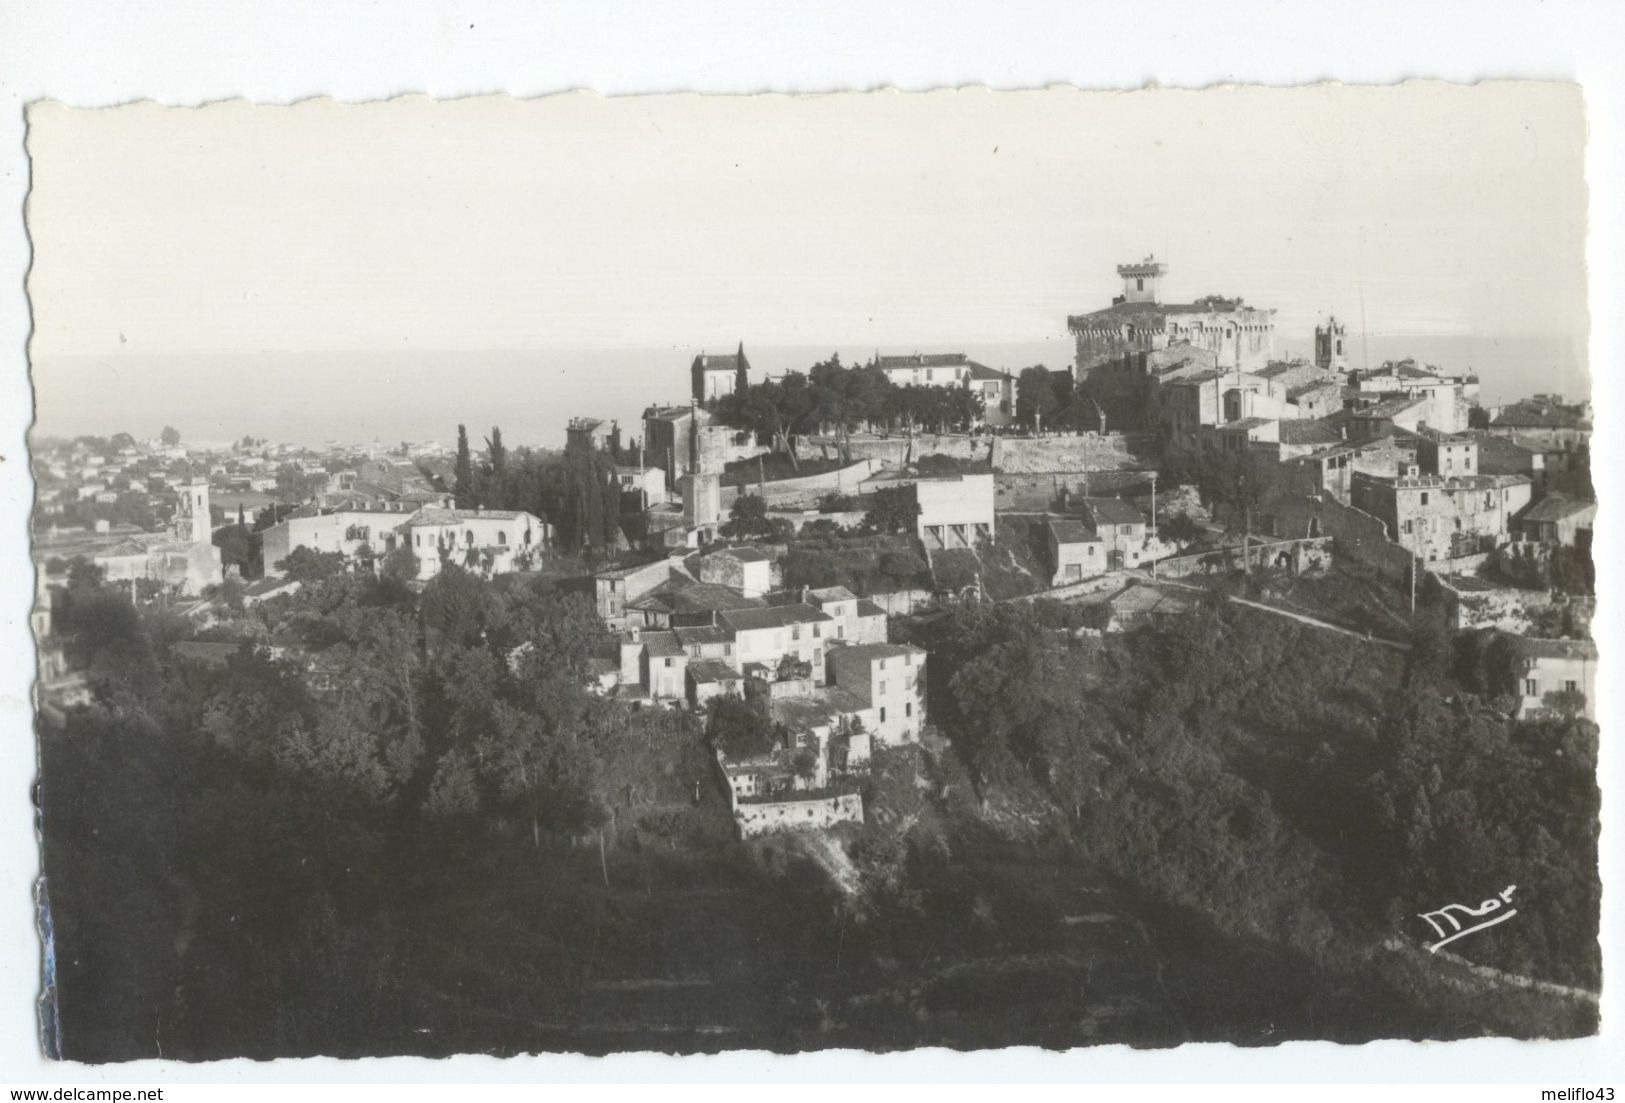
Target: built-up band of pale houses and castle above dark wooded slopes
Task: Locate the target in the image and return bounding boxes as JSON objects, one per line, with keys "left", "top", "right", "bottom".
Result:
{"left": 34, "top": 258, "right": 1596, "bottom": 837}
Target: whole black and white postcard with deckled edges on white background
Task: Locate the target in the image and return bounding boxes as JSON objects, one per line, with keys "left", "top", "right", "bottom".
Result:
{"left": 15, "top": 81, "right": 1602, "bottom": 1062}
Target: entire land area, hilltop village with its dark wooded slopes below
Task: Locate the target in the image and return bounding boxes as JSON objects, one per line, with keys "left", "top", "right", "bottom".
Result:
{"left": 33, "top": 258, "right": 1601, "bottom": 1059}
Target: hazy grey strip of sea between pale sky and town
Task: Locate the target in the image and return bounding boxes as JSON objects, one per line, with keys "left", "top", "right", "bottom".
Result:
{"left": 33, "top": 333, "right": 1591, "bottom": 448}
